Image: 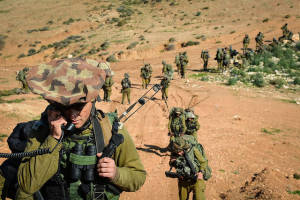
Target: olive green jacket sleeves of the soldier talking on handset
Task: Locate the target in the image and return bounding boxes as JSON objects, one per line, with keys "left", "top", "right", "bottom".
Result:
{"left": 17, "top": 113, "right": 146, "bottom": 199}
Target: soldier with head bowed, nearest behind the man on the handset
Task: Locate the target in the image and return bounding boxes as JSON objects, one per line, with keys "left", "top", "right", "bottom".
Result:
{"left": 166, "top": 135, "right": 211, "bottom": 200}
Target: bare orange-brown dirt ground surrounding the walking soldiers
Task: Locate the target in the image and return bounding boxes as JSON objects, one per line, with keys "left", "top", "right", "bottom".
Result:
{"left": 0, "top": 0, "right": 300, "bottom": 200}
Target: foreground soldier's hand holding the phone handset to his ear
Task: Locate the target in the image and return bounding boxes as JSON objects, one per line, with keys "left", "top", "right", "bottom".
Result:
{"left": 47, "top": 109, "right": 67, "bottom": 139}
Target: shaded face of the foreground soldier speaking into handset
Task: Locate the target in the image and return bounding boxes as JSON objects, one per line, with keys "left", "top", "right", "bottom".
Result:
{"left": 63, "top": 102, "right": 92, "bottom": 128}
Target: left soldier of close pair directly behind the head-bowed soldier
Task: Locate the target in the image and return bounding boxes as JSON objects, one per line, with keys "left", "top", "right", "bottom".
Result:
{"left": 168, "top": 107, "right": 186, "bottom": 137}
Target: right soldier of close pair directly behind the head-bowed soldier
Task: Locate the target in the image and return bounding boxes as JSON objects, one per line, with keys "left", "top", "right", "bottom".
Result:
{"left": 185, "top": 110, "right": 200, "bottom": 141}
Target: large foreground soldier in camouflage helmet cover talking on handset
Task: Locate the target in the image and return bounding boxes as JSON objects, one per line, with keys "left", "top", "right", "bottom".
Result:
{"left": 7, "top": 58, "right": 146, "bottom": 200}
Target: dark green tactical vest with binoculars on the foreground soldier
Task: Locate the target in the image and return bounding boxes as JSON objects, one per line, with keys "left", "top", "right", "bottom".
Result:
{"left": 40, "top": 112, "right": 122, "bottom": 200}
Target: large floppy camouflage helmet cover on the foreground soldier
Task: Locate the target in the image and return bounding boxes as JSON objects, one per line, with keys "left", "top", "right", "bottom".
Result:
{"left": 26, "top": 58, "right": 106, "bottom": 106}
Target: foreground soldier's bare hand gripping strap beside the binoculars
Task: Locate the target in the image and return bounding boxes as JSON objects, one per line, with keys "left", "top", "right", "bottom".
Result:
{"left": 97, "top": 153, "right": 117, "bottom": 180}
